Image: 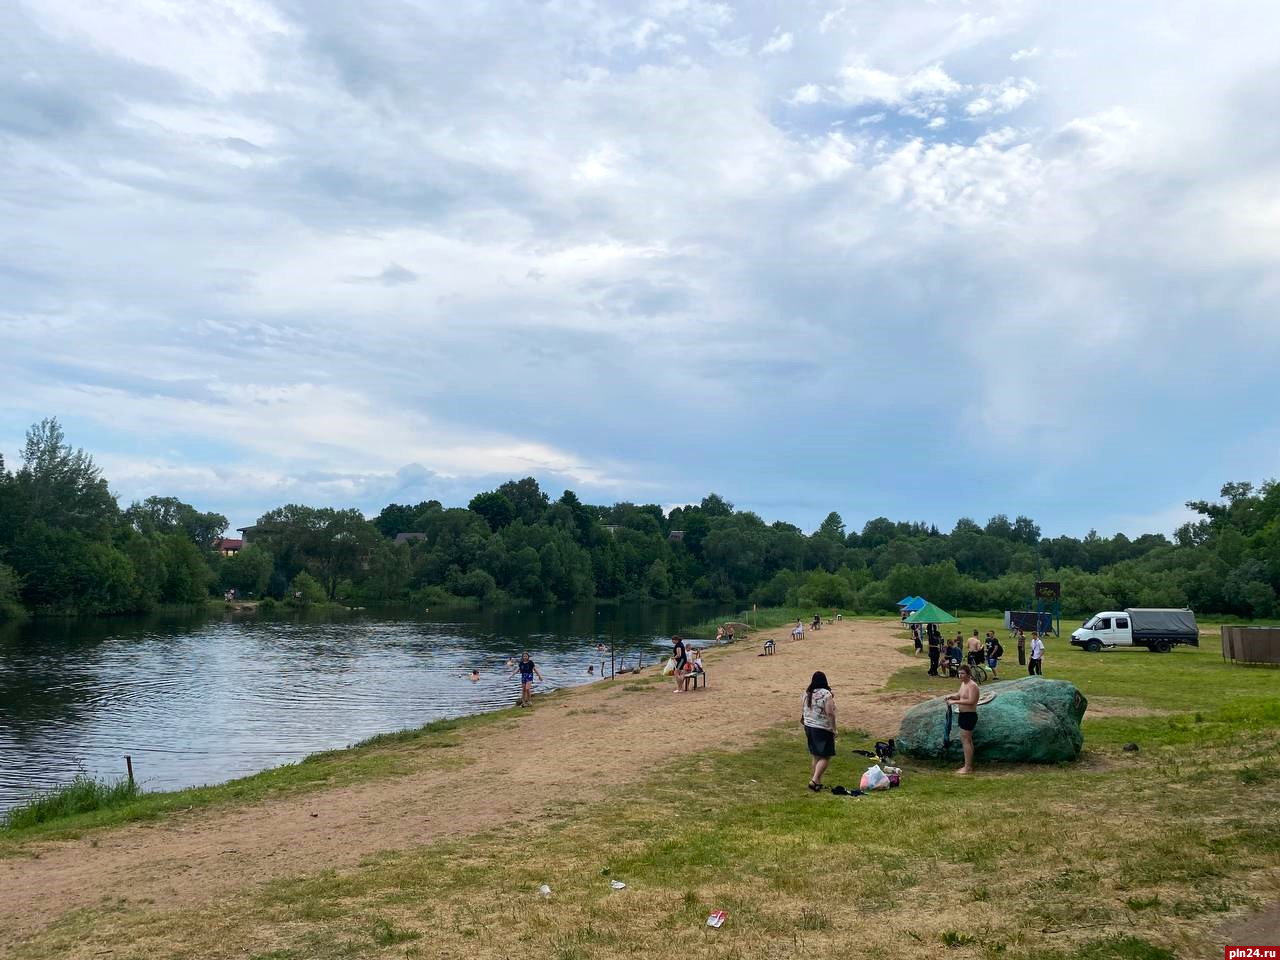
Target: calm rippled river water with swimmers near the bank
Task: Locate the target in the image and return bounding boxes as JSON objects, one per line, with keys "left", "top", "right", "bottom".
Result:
{"left": 0, "top": 605, "right": 719, "bottom": 809}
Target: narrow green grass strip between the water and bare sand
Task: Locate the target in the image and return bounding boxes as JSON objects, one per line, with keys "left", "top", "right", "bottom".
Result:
{"left": 0, "top": 709, "right": 513, "bottom": 856}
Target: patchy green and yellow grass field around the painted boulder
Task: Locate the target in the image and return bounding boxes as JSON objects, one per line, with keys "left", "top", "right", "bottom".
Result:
{"left": 7, "top": 620, "right": 1280, "bottom": 960}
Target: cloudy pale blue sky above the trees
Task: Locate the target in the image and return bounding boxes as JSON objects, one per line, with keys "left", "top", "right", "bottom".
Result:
{"left": 0, "top": 0, "right": 1280, "bottom": 535}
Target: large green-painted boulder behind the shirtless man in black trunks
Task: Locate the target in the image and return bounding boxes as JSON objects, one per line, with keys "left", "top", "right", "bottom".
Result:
{"left": 897, "top": 677, "right": 1089, "bottom": 763}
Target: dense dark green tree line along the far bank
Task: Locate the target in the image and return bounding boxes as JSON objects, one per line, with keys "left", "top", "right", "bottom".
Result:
{"left": 0, "top": 420, "right": 1280, "bottom": 617}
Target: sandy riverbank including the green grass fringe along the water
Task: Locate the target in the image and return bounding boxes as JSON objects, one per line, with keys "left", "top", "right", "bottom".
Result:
{"left": 0, "top": 621, "right": 919, "bottom": 942}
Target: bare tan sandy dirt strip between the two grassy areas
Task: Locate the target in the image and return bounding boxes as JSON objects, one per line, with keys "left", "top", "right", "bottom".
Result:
{"left": 0, "top": 621, "right": 922, "bottom": 947}
